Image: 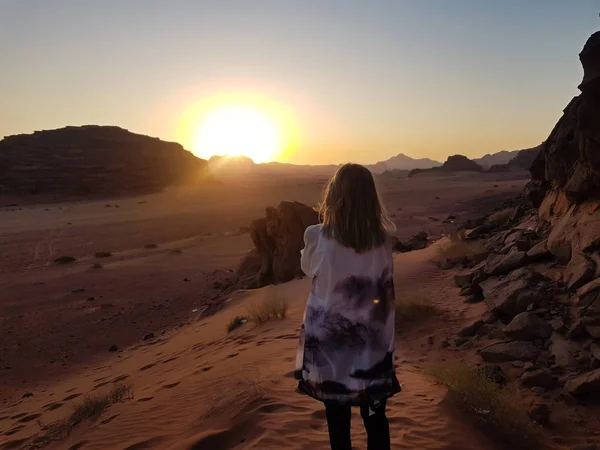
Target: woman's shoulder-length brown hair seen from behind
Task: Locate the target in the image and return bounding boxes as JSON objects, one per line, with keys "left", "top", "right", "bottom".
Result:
{"left": 319, "top": 164, "right": 395, "bottom": 253}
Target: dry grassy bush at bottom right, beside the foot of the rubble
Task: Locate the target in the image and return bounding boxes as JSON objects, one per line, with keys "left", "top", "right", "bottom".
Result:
{"left": 428, "top": 363, "right": 539, "bottom": 449}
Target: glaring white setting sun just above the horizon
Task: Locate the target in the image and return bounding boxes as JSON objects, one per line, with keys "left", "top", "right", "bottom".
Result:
{"left": 193, "top": 105, "right": 282, "bottom": 163}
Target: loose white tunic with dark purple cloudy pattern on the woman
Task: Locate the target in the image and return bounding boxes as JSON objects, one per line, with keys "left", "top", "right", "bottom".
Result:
{"left": 296, "top": 225, "right": 400, "bottom": 405}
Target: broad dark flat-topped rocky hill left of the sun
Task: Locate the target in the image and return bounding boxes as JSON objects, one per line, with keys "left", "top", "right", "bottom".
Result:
{"left": 0, "top": 125, "right": 206, "bottom": 197}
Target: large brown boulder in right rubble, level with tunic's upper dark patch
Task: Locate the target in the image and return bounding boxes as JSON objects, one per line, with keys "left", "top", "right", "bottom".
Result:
{"left": 480, "top": 267, "right": 550, "bottom": 316}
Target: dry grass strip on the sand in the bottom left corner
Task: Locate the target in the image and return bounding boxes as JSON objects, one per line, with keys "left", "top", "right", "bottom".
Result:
{"left": 28, "top": 384, "right": 133, "bottom": 450}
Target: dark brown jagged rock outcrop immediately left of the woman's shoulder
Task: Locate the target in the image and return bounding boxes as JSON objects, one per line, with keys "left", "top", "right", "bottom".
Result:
{"left": 237, "top": 202, "right": 319, "bottom": 288}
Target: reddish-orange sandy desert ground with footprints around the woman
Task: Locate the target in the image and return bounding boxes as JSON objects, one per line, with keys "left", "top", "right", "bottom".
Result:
{"left": 0, "top": 170, "right": 570, "bottom": 450}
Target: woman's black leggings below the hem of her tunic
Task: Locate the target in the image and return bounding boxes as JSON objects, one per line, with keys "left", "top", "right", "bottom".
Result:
{"left": 325, "top": 401, "right": 390, "bottom": 450}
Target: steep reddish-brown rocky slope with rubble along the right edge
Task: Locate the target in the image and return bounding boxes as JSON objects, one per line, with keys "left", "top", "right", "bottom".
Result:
{"left": 444, "top": 32, "right": 600, "bottom": 422}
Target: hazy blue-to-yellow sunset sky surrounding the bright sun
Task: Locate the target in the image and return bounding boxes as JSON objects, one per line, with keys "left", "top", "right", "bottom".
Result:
{"left": 0, "top": 0, "right": 600, "bottom": 164}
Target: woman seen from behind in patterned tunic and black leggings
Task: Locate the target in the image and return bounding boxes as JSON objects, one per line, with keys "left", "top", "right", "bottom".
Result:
{"left": 296, "top": 164, "right": 400, "bottom": 450}
